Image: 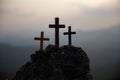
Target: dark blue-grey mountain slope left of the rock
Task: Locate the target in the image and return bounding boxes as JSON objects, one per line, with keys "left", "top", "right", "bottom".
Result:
{"left": 0, "top": 43, "right": 35, "bottom": 73}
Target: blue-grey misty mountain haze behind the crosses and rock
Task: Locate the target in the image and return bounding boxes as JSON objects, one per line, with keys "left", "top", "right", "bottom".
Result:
{"left": 0, "top": 25, "right": 120, "bottom": 80}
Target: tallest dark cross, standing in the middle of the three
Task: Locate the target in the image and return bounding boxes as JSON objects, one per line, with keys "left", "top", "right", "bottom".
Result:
{"left": 49, "top": 17, "right": 65, "bottom": 48}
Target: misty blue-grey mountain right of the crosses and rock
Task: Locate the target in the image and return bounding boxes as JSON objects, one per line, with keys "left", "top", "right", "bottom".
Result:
{"left": 74, "top": 26, "right": 120, "bottom": 67}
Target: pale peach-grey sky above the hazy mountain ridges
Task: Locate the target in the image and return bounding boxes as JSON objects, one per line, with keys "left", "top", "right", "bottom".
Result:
{"left": 0, "top": 0, "right": 120, "bottom": 44}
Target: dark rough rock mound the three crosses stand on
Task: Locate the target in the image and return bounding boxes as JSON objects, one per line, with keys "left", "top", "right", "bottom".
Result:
{"left": 13, "top": 45, "right": 92, "bottom": 80}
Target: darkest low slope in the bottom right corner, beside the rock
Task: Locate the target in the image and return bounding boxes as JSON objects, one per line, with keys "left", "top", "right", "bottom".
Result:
{"left": 93, "top": 61, "right": 120, "bottom": 80}
